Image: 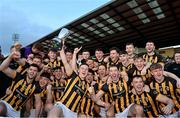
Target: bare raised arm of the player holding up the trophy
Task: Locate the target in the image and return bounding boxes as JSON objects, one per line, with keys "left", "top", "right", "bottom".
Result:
{"left": 60, "top": 40, "right": 73, "bottom": 76}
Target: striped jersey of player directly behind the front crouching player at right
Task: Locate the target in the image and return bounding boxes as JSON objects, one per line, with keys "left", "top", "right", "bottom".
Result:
{"left": 128, "top": 66, "right": 152, "bottom": 85}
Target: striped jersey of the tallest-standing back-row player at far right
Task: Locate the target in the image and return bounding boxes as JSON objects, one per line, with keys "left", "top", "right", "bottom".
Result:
{"left": 143, "top": 53, "right": 165, "bottom": 63}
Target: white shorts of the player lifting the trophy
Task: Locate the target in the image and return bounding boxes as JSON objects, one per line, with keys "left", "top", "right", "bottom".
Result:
{"left": 54, "top": 102, "right": 77, "bottom": 118}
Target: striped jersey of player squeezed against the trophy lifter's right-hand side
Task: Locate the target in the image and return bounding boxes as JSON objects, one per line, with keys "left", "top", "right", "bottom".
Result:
{"left": 79, "top": 83, "right": 94, "bottom": 116}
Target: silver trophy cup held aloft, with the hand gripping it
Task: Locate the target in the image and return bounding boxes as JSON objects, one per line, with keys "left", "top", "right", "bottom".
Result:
{"left": 54, "top": 28, "right": 70, "bottom": 50}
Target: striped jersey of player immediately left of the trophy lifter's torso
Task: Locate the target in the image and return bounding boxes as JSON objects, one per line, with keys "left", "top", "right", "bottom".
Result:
{"left": 52, "top": 78, "right": 67, "bottom": 102}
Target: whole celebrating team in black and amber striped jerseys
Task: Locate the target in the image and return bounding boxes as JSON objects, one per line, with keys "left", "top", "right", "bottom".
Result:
{"left": 0, "top": 41, "right": 180, "bottom": 117}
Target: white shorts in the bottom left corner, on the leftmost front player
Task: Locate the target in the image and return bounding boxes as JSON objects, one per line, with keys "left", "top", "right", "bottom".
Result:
{"left": 0, "top": 100, "right": 20, "bottom": 118}
